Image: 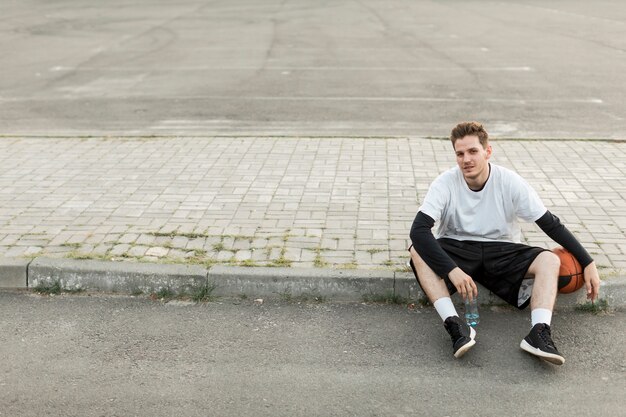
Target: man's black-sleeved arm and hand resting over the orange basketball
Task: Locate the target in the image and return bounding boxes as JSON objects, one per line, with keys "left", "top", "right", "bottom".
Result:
{"left": 536, "top": 210, "right": 600, "bottom": 301}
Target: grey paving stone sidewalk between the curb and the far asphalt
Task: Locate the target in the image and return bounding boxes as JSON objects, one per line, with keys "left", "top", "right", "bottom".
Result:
{"left": 0, "top": 137, "right": 626, "bottom": 275}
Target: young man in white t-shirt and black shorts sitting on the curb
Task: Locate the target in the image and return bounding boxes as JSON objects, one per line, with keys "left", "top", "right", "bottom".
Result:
{"left": 409, "top": 122, "right": 600, "bottom": 365}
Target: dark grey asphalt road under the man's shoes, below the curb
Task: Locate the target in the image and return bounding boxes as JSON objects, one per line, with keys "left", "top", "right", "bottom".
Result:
{"left": 0, "top": 292, "right": 626, "bottom": 417}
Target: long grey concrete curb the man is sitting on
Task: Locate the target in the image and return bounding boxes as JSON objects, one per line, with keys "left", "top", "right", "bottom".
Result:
{"left": 0, "top": 258, "right": 626, "bottom": 308}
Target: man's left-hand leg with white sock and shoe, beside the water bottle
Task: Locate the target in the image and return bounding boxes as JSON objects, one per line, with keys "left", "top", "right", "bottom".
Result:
{"left": 409, "top": 247, "right": 476, "bottom": 358}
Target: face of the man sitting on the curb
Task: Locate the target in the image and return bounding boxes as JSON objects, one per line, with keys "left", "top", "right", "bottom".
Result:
{"left": 454, "top": 135, "right": 491, "bottom": 183}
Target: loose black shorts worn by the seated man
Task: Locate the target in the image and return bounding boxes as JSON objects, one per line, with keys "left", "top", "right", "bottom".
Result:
{"left": 411, "top": 238, "right": 548, "bottom": 310}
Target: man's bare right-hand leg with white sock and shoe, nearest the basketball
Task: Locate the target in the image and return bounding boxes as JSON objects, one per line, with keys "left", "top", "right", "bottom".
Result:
{"left": 520, "top": 251, "right": 565, "bottom": 365}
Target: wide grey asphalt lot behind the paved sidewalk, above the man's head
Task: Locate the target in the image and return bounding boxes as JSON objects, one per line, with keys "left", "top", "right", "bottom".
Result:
{"left": 0, "top": 0, "right": 626, "bottom": 139}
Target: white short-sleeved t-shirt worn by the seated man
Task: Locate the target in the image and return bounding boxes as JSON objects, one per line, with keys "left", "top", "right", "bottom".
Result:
{"left": 420, "top": 164, "right": 546, "bottom": 243}
